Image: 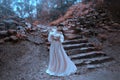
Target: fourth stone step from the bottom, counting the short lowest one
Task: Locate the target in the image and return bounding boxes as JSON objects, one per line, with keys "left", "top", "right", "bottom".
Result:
{"left": 66, "top": 47, "right": 101, "bottom": 55}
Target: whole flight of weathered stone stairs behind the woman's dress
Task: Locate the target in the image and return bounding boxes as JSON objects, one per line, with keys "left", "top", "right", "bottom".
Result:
{"left": 40, "top": 18, "right": 113, "bottom": 72}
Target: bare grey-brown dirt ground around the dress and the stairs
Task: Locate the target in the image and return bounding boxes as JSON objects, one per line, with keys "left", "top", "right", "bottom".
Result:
{"left": 0, "top": 28, "right": 120, "bottom": 80}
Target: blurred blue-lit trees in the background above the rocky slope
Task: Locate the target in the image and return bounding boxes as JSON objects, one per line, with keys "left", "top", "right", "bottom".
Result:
{"left": 0, "top": 0, "right": 81, "bottom": 20}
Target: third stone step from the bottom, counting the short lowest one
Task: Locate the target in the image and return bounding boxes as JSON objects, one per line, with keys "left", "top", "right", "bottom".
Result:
{"left": 70, "top": 51, "right": 107, "bottom": 60}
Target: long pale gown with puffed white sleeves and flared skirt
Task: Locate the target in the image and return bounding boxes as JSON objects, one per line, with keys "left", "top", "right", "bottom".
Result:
{"left": 46, "top": 32, "right": 77, "bottom": 76}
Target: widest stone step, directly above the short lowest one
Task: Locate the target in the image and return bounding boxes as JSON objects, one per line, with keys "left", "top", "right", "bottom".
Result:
{"left": 73, "top": 56, "right": 113, "bottom": 66}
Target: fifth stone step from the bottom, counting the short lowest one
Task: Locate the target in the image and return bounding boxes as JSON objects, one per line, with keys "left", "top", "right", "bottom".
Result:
{"left": 63, "top": 43, "right": 94, "bottom": 50}
